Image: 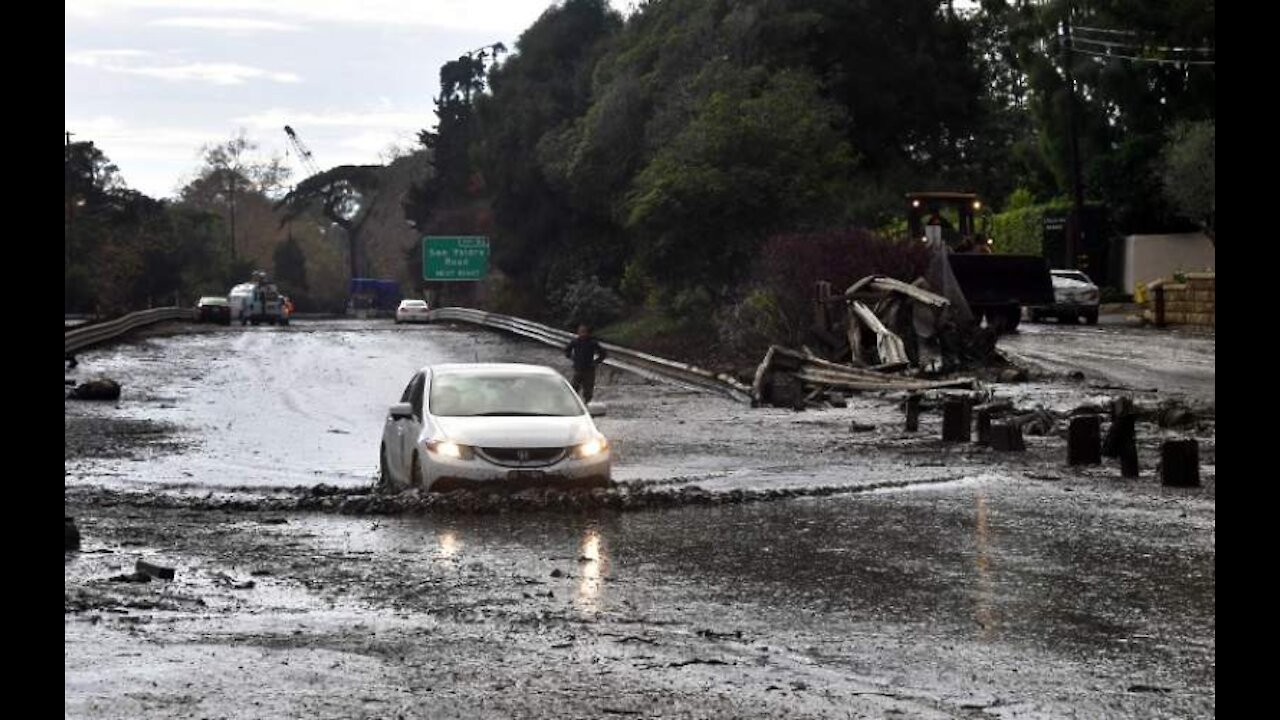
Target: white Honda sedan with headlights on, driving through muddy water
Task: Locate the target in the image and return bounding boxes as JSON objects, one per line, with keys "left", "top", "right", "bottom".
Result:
{"left": 379, "top": 364, "right": 611, "bottom": 492}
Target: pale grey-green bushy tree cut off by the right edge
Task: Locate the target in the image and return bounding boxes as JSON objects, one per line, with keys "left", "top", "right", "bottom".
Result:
{"left": 1161, "top": 120, "right": 1217, "bottom": 245}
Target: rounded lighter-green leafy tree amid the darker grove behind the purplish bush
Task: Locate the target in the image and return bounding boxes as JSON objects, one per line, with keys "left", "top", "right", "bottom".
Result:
{"left": 627, "top": 68, "right": 855, "bottom": 296}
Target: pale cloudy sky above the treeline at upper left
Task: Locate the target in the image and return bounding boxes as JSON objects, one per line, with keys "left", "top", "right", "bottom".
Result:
{"left": 64, "top": 0, "right": 630, "bottom": 197}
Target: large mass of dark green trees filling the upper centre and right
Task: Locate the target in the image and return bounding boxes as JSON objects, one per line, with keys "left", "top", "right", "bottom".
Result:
{"left": 406, "top": 0, "right": 1215, "bottom": 330}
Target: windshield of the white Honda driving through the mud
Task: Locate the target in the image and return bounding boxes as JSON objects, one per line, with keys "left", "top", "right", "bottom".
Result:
{"left": 428, "top": 373, "right": 582, "bottom": 418}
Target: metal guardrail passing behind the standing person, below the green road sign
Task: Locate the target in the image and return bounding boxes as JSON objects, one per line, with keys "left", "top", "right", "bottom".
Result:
{"left": 429, "top": 307, "right": 751, "bottom": 402}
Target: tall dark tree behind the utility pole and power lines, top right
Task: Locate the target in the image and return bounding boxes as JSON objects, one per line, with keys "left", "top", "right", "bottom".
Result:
{"left": 983, "top": 0, "right": 1216, "bottom": 231}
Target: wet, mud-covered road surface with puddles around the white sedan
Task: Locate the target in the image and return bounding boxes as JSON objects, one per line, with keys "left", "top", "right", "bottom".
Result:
{"left": 64, "top": 323, "right": 1216, "bottom": 717}
